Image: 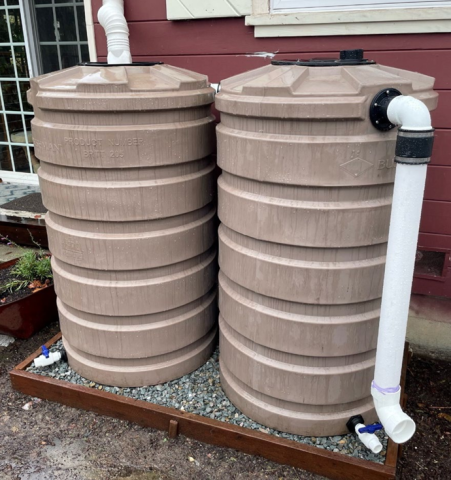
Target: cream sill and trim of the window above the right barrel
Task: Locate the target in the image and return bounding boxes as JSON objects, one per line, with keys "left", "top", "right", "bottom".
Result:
{"left": 246, "top": 0, "right": 451, "bottom": 37}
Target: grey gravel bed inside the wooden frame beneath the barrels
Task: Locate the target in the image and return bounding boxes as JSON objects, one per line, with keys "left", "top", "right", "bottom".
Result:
{"left": 27, "top": 340, "right": 388, "bottom": 464}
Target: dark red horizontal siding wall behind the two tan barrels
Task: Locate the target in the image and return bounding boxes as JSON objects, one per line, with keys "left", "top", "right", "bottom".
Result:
{"left": 92, "top": 0, "right": 451, "bottom": 297}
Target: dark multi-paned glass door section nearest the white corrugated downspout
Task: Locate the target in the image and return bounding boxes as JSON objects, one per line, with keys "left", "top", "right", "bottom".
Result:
{"left": 34, "top": 0, "right": 89, "bottom": 73}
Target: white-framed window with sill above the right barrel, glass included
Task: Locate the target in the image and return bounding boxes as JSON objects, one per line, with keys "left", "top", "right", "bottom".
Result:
{"left": 246, "top": 0, "right": 451, "bottom": 37}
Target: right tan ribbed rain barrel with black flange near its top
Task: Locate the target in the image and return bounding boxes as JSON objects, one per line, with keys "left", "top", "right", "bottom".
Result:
{"left": 216, "top": 52, "right": 436, "bottom": 435}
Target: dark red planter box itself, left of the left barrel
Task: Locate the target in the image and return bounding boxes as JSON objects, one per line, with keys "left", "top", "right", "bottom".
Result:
{"left": 0, "top": 259, "right": 58, "bottom": 338}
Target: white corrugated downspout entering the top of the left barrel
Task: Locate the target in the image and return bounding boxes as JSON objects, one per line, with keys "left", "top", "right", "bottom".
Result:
{"left": 97, "top": 0, "right": 132, "bottom": 65}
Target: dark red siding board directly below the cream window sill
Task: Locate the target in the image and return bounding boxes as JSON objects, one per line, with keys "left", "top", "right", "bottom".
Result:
{"left": 96, "top": 18, "right": 451, "bottom": 56}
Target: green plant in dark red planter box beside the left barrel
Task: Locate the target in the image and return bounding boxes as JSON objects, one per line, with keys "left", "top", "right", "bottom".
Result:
{"left": 0, "top": 238, "right": 58, "bottom": 338}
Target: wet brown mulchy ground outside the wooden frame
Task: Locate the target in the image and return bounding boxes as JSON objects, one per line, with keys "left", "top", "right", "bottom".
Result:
{"left": 0, "top": 324, "right": 451, "bottom": 480}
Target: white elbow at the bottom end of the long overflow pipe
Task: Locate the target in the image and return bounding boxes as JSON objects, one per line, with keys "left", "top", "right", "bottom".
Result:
{"left": 371, "top": 387, "right": 416, "bottom": 443}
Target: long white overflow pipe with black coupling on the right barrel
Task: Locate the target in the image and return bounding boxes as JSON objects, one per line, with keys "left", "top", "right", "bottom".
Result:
{"left": 371, "top": 92, "right": 434, "bottom": 443}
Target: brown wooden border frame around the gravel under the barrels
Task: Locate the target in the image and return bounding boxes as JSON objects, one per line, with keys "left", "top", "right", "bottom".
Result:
{"left": 10, "top": 333, "right": 409, "bottom": 480}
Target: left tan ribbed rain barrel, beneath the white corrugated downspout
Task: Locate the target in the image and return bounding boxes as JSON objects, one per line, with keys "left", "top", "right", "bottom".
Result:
{"left": 29, "top": 64, "right": 217, "bottom": 386}
